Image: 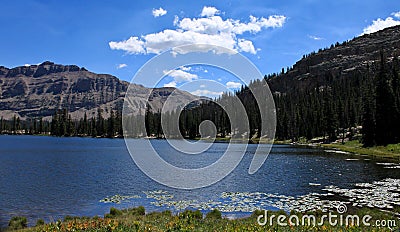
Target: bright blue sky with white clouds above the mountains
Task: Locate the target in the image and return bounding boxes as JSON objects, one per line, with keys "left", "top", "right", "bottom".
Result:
{"left": 0, "top": 0, "right": 400, "bottom": 96}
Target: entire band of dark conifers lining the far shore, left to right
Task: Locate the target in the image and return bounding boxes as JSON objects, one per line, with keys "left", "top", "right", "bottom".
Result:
{"left": 0, "top": 53, "right": 400, "bottom": 146}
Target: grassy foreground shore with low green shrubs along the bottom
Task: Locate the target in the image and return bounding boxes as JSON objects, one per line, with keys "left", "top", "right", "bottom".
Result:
{"left": 6, "top": 207, "right": 400, "bottom": 232}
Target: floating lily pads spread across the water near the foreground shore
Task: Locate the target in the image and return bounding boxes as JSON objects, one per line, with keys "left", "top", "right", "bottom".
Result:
{"left": 101, "top": 178, "right": 400, "bottom": 217}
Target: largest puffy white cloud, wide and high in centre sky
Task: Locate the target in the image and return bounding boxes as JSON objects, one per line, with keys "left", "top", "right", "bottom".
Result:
{"left": 109, "top": 7, "right": 286, "bottom": 54}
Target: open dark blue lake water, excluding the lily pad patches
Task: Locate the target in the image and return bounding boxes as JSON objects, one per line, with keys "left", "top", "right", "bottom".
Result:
{"left": 0, "top": 136, "right": 400, "bottom": 227}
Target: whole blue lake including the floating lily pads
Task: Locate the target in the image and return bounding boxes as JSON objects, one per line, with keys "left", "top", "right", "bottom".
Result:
{"left": 0, "top": 135, "right": 400, "bottom": 227}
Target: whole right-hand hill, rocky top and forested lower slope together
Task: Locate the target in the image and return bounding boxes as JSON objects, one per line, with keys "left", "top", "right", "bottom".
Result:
{"left": 166, "top": 26, "right": 400, "bottom": 143}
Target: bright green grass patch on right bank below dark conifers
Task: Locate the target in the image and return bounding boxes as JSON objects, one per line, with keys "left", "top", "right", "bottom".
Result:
{"left": 322, "top": 140, "right": 400, "bottom": 161}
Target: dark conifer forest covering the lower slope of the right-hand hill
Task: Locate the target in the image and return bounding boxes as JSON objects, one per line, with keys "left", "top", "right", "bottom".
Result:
{"left": 150, "top": 52, "right": 400, "bottom": 147}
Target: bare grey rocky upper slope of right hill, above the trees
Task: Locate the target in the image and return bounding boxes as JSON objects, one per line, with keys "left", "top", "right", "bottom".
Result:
{"left": 267, "top": 26, "right": 400, "bottom": 93}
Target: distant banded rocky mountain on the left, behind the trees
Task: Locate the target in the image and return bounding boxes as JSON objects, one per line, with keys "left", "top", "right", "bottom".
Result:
{"left": 0, "top": 61, "right": 197, "bottom": 119}
